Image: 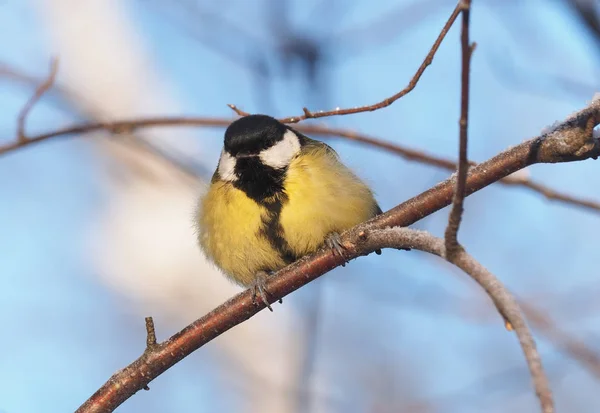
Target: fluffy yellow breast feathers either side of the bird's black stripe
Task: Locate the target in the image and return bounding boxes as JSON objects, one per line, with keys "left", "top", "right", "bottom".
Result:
{"left": 198, "top": 145, "right": 379, "bottom": 286}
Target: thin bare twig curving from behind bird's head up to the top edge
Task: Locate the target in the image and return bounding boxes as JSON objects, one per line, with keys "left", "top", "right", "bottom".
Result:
{"left": 280, "top": 1, "right": 465, "bottom": 123}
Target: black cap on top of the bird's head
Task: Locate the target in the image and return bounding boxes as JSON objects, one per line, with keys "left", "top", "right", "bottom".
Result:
{"left": 224, "top": 115, "right": 288, "bottom": 156}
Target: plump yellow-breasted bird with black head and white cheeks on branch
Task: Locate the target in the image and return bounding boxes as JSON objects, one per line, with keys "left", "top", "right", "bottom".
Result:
{"left": 195, "top": 114, "right": 382, "bottom": 311}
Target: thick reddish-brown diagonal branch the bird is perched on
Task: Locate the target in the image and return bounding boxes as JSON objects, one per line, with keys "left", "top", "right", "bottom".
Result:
{"left": 77, "top": 100, "right": 600, "bottom": 413}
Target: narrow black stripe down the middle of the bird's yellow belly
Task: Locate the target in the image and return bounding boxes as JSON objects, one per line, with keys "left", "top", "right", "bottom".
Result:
{"left": 259, "top": 192, "right": 298, "bottom": 264}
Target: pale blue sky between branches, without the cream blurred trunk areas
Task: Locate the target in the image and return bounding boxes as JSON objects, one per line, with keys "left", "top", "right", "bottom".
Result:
{"left": 0, "top": 0, "right": 600, "bottom": 413}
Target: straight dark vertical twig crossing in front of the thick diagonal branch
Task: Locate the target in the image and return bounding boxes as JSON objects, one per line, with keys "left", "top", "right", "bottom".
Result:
{"left": 444, "top": 0, "right": 475, "bottom": 260}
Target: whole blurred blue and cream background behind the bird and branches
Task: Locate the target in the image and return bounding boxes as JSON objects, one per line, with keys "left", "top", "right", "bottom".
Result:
{"left": 0, "top": 0, "right": 600, "bottom": 413}
